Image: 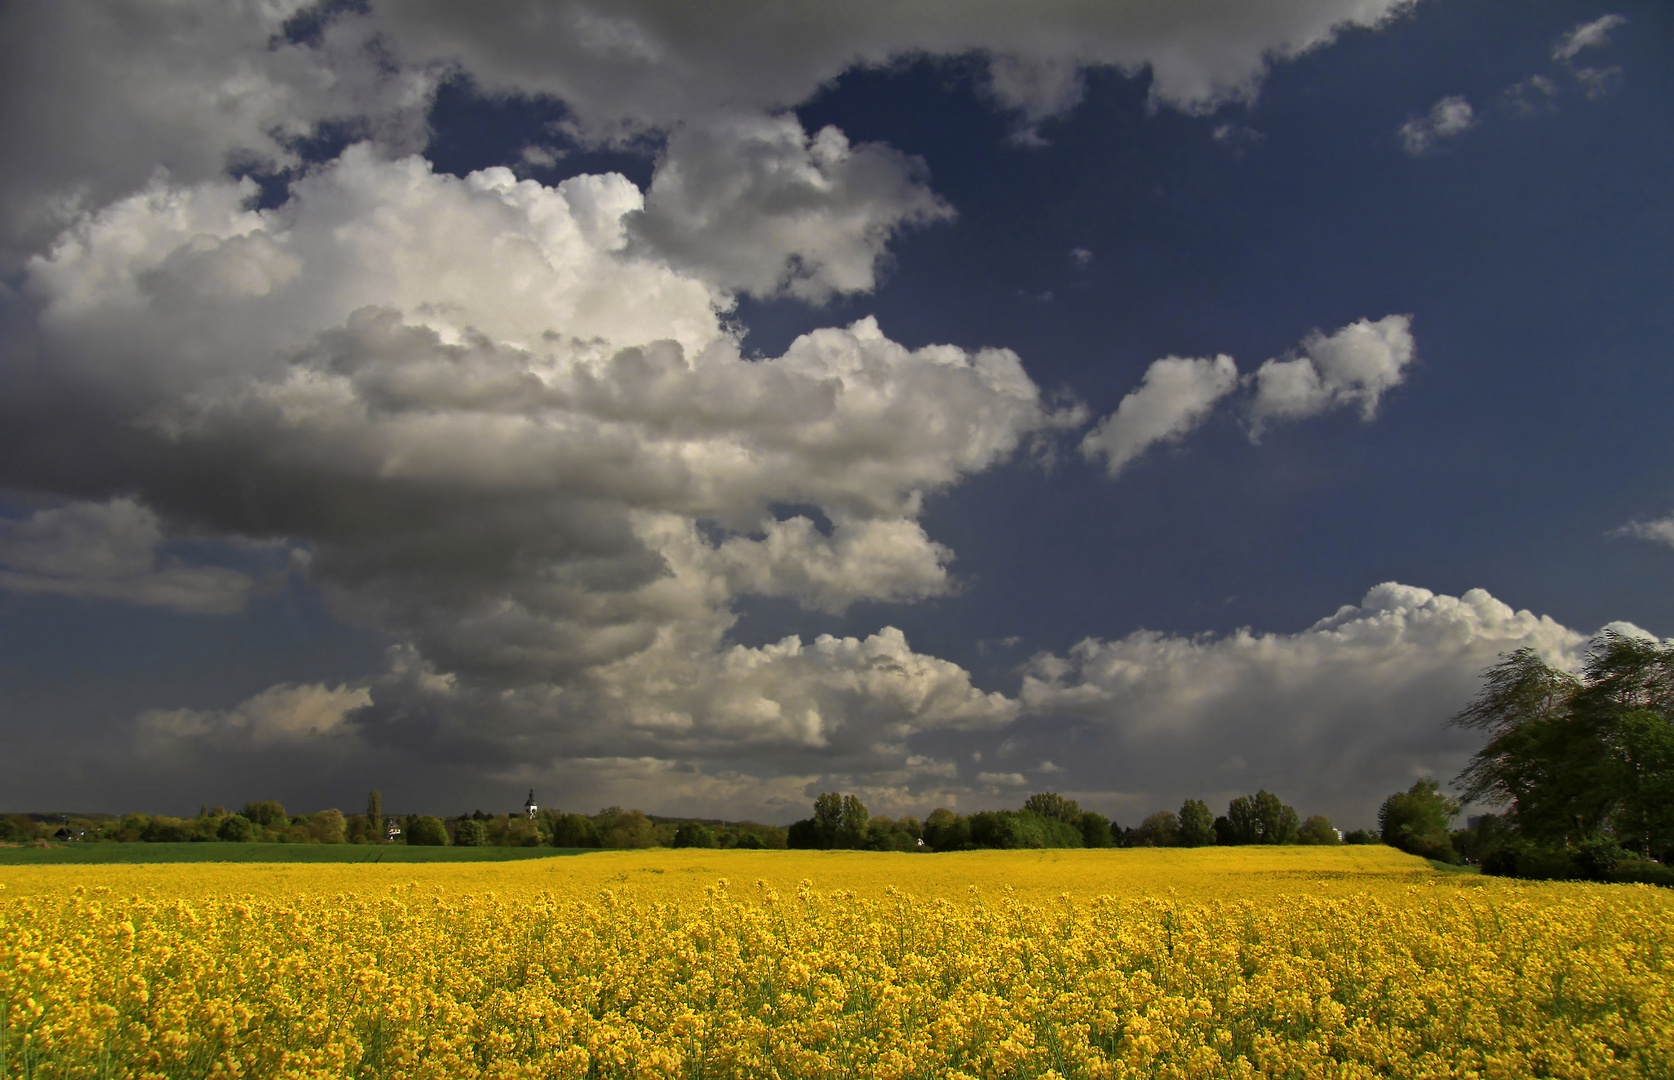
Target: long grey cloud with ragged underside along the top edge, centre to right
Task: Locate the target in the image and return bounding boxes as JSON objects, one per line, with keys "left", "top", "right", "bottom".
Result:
{"left": 375, "top": 0, "right": 1411, "bottom": 139}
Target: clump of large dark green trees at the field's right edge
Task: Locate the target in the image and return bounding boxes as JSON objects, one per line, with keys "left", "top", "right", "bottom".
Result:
{"left": 1419, "top": 631, "right": 1674, "bottom": 884}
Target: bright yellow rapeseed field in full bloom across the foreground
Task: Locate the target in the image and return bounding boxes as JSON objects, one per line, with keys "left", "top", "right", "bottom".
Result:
{"left": 0, "top": 847, "right": 1674, "bottom": 1080}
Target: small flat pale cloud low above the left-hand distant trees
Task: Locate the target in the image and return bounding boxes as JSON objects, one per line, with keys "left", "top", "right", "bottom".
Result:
{"left": 136, "top": 683, "right": 372, "bottom": 753}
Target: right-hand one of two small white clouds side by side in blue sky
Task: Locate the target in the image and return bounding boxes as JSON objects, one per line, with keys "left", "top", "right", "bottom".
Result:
{"left": 1250, "top": 315, "right": 1415, "bottom": 439}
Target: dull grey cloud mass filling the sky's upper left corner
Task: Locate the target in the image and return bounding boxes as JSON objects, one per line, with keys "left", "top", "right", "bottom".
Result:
{"left": 0, "top": 0, "right": 435, "bottom": 270}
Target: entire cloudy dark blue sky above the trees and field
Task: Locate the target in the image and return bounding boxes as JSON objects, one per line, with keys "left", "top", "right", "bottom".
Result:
{"left": 0, "top": 0, "right": 1674, "bottom": 829}
